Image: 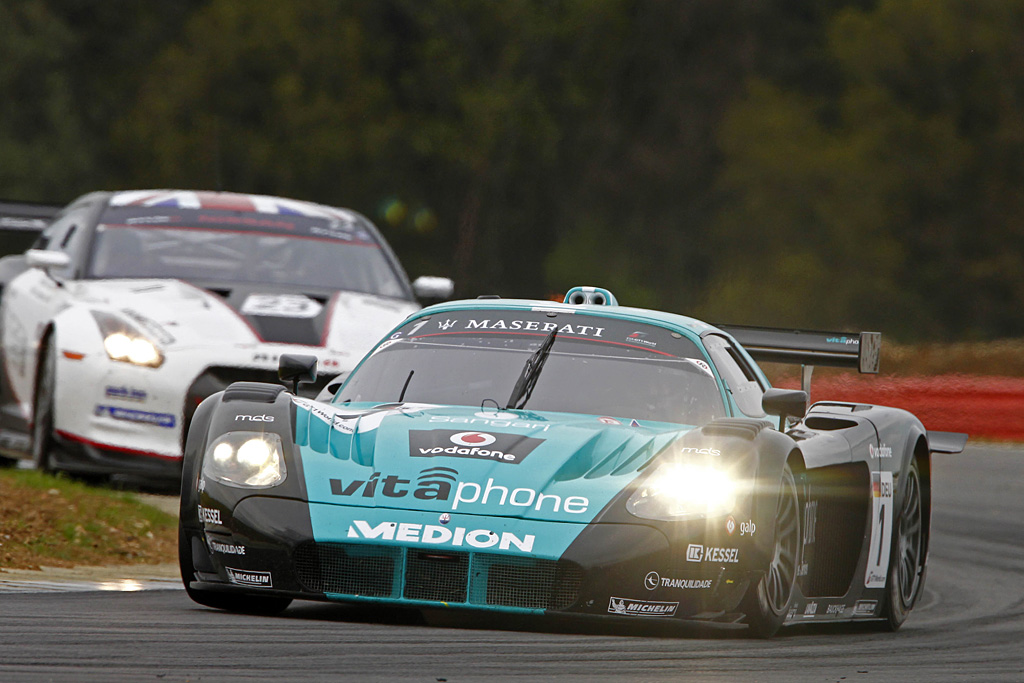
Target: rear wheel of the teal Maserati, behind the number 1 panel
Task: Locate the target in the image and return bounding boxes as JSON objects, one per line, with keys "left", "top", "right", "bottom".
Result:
{"left": 882, "top": 459, "right": 926, "bottom": 631}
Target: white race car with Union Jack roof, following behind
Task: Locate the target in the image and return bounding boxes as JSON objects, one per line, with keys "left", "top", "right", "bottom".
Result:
{"left": 0, "top": 189, "right": 453, "bottom": 483}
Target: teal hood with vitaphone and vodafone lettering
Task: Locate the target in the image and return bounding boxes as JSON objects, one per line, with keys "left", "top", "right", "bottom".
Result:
{"left": 293, "top": 398, "right": 687, "bottom": 523}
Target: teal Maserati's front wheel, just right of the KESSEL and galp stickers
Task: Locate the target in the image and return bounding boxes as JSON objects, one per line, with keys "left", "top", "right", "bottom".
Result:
{"left": 740, "top": 463, "right": 800, "bottom": 638}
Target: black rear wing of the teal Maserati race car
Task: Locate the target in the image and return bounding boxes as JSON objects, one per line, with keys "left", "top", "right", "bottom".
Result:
{"left": 717, "top": 325, "right": 882, "bottom": 395}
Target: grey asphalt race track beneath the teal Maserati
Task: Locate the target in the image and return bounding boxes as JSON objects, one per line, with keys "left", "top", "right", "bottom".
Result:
{"left": 0, "top": 446, "right": 1024, "bottom": 683}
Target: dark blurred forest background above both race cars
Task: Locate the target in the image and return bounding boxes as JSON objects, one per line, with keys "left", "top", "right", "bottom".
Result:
{"left": 0, "top": 0, "right": 1024, "bottom": 343}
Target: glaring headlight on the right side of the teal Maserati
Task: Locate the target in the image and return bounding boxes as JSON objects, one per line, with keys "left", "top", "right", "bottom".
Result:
{"left": 626, "top": 463, "right": 736, "bottom": 520}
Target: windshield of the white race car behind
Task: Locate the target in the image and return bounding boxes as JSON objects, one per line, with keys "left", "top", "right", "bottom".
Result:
{"left": 87, "top": 206, "right": 410, "bottom": 299}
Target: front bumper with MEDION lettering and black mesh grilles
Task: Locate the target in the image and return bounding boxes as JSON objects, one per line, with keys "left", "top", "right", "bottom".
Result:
{"left": 184, "top": 496, "right": 751, "bottom": 618}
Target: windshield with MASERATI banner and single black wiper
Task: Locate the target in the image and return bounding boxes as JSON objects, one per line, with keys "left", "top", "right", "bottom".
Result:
{"left": 335, "top": 310, "right": 725, "bottom": 425}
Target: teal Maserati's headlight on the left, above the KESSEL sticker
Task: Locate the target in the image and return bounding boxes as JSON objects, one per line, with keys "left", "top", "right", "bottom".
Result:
{"left": 203, "top": 432, "right": 287, "bottom": 488}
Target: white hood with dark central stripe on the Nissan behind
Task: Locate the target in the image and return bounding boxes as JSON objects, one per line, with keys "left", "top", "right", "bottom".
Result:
{"left": 76, "top": 280, "right": 418, "bottom": 358}
